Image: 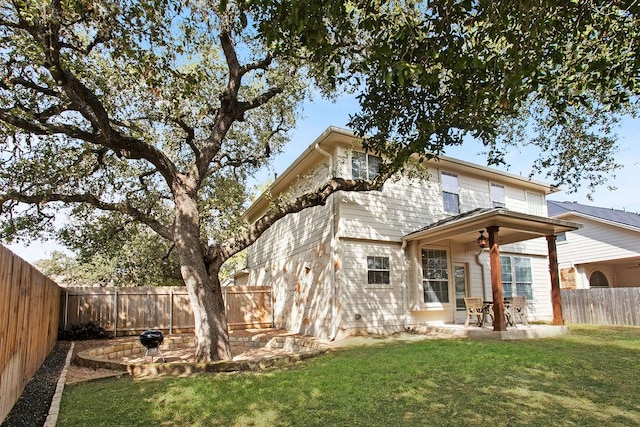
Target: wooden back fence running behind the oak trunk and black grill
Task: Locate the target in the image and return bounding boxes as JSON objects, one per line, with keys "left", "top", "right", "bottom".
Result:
{"left": 60, "top": 286, "right": 273, "bottom": 336}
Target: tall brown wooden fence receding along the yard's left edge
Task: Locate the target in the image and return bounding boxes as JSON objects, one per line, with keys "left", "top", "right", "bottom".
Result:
{"left": 0, "top": 245, "right": 60, "bottom": 421}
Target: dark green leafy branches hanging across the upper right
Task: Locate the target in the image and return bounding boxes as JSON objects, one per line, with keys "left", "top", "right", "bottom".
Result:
{"left": 245, "top": 0, "right": 640, "bottom": 190}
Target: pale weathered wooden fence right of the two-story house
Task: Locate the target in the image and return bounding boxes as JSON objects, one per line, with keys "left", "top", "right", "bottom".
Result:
{"left": 560, "top": 288, "right": 640, "bottom": 326}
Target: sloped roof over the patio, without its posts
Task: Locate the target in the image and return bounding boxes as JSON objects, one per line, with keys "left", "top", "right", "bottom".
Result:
{"left": 404, "top": 208, "right": 582, "bottom": 248}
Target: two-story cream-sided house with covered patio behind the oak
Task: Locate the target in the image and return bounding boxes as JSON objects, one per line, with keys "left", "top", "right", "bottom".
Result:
{"left": 243, "top": 128, "right": 578, "bottom": 339}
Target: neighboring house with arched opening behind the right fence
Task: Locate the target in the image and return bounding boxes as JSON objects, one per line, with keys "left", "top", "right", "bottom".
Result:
{"left": 547, "top": 200, "right": 640, "bottom": 289}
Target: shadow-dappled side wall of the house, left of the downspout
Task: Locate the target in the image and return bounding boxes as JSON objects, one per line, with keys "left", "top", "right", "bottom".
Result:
{"left": 247, "top": 203, "right": 334, "bottom": 338}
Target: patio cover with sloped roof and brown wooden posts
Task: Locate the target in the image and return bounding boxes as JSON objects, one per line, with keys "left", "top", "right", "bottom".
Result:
{"left": 404, "top": 208, "right": 581, "bottom": 335}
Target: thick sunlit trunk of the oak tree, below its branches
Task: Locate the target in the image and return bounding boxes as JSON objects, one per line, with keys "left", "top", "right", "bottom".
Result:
{"left": 174, "top": 194, "right": 231, "bottom": 362}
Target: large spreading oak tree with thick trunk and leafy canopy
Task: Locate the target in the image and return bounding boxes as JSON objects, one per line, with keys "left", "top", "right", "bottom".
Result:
{"left": 0, "top": 0, "right": 640, "bottom": 361}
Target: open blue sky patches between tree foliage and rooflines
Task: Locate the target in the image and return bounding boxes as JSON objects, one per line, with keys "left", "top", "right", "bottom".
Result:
{"left": 9, "top": 96, "right": 640, "bottom": 262}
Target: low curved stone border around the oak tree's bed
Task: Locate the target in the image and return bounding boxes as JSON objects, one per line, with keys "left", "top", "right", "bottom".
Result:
{"left": 76, "top": 335, "right": 330, "bottom": 377}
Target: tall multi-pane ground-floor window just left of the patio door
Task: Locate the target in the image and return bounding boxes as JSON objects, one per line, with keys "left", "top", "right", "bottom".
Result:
{"left": 422, "top": 249, "right": 449, "bottom": 303}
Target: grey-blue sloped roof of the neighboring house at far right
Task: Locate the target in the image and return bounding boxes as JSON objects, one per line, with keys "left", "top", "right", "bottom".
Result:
{"left": 547, "top": 200, "right": 640, "bottom": 231}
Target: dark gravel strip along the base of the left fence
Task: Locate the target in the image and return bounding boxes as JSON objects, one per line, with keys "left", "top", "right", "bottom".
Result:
{"left": 1, "top": 341, "right": 71, "bottom": 427}
